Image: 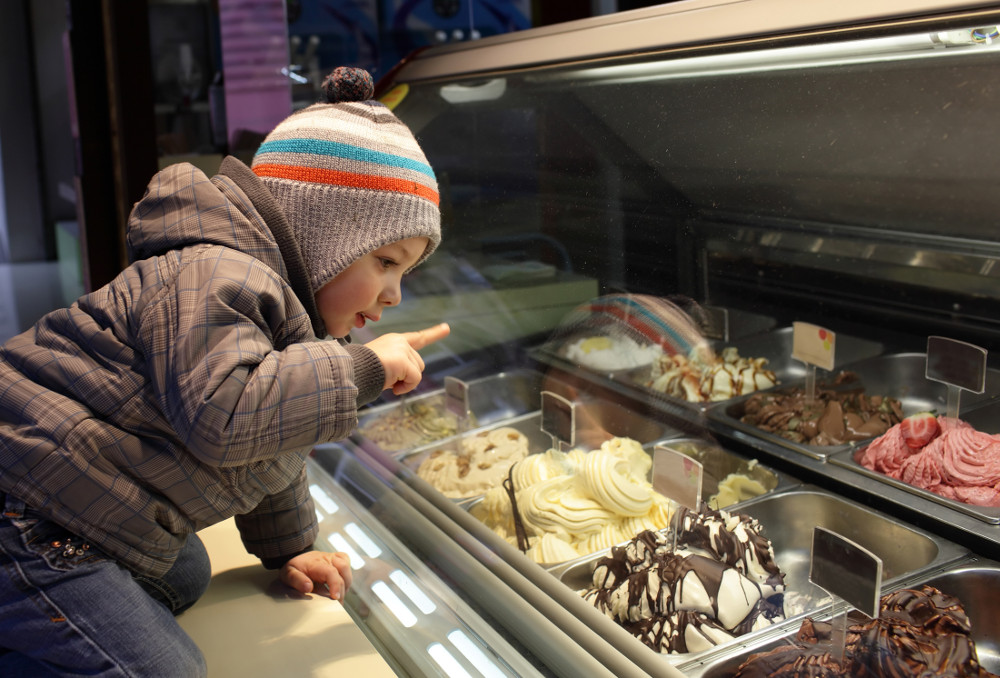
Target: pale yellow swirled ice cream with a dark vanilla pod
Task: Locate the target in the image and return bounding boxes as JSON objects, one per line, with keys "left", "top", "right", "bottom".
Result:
{"left": 470, "top": 438, "right": 673, "bottom": 563}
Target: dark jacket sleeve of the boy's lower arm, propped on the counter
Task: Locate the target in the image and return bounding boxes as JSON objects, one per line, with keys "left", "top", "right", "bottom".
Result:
{"left": 235, "top": 467, "right": 318, "bottom": 569}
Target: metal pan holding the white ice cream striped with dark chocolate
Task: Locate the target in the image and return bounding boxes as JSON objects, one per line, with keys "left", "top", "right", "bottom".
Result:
{"left": 550, "top": 486, "right": 968, "bottom": 670}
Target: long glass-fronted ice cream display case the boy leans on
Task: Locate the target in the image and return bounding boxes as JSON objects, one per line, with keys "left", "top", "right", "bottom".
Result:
{"left": 302, "top": 0, "right": 1000, "bottom": 676}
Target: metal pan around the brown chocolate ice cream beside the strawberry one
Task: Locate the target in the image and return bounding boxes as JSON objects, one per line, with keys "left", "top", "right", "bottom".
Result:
{"left": 707, "top": 356, "right": 974, "bottom": 460}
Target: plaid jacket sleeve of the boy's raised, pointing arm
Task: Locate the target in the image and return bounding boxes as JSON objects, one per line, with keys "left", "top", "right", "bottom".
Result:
{"left": 140, "top": 246, "right": 358, "bottom": 467}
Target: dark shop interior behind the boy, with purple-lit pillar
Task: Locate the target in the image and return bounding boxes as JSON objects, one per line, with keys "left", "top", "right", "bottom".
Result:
{"left": 0, "top": 0, "right": 672, "bottom": 341}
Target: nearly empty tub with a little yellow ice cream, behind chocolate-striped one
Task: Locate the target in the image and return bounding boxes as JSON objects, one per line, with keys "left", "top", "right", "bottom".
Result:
{"left": 667, "top": 438, "right": 800, "bottom": 510}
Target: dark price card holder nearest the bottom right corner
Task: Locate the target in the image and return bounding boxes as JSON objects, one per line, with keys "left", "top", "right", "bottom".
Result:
{"left": 809, "top": 526, "right": 882, "bottom": 661}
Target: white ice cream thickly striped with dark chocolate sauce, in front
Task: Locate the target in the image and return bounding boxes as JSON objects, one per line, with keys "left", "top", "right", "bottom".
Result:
{"left": 581, "top": 509, "right": 784, "bottom": 654}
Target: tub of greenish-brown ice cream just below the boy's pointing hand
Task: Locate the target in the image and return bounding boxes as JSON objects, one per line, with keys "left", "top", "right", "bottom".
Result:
{"left": 351, "top": 369, "right": 545, "bottom": 453}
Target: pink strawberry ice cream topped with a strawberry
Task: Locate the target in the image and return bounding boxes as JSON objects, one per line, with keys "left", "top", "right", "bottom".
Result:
{"left": 859, "top": 413, "right": 1000, "bottom": 506}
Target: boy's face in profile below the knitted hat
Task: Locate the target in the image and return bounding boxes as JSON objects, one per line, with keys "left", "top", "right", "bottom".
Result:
{"left": 316, "top": 236, "right": 428, "bottom": 337}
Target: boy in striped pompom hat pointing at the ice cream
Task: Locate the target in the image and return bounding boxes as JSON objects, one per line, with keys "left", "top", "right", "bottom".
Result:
{"left": 0, "top": 69, "right": 449, "bottom": 678}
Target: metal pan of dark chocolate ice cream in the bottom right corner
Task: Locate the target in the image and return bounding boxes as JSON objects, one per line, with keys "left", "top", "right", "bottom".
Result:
{"left": 685, "top": 565, "right": 1000, "bottom": 678}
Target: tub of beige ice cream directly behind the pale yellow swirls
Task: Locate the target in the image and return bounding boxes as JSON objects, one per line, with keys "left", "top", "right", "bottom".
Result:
{"left": 398, "top": 400, "right": 681, "bottom": 503}
